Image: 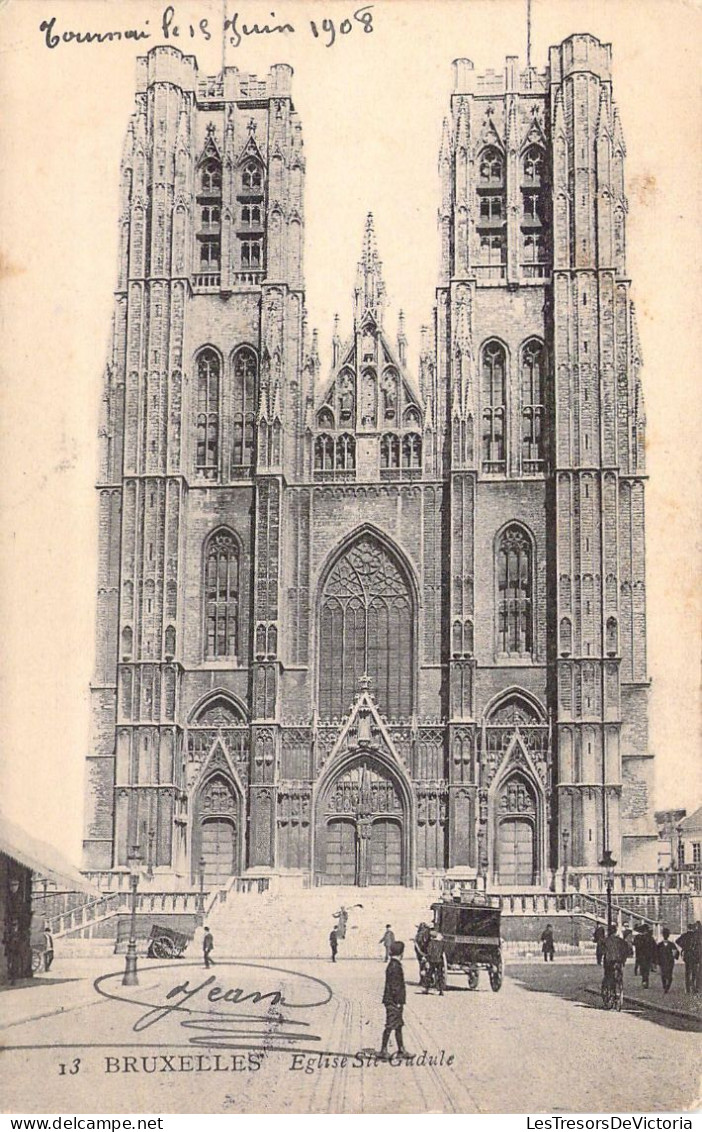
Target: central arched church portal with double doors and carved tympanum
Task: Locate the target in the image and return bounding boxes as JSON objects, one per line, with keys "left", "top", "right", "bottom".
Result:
{"left": 317, "top": 752, "right": 408, "bottom": 887}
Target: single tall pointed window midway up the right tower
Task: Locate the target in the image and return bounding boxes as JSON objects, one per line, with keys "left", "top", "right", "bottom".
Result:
{"left": 496, "top": 523, "right": 533, "bottom": 657}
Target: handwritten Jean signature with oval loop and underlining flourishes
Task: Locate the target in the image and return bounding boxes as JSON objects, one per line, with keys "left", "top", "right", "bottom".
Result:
{"left": 93, "top": 962, "right": 332, "bottom": 1050}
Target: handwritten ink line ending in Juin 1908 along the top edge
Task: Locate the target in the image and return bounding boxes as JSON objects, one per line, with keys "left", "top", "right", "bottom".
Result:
{"left": 38, "top": 5, "right": 374, "bottom": 49}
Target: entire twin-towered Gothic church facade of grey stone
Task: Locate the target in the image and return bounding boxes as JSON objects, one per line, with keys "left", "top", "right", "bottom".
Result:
{"left": 85, "top": 35, "right": 656, "bottom": 887}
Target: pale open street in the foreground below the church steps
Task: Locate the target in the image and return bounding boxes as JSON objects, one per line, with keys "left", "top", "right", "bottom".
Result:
{"left": 0, "top": 960, "right": 700, "bottom": 1113}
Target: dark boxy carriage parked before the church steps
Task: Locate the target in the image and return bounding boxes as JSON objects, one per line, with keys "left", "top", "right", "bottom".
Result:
{"left": 431, "top": 894, "right": 504, "bottom": 992}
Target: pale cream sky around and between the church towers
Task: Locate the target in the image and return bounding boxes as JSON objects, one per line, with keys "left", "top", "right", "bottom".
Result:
{"left": 0, "top": 0, "right": 702, "bottom": 863}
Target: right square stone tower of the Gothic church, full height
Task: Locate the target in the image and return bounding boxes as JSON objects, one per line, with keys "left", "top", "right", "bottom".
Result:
{"left": 435, "top": 35, "right": 651, "bottom": 883}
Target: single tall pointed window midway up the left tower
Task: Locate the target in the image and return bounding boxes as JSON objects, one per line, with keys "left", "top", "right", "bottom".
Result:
{"left": 204, "top": 530, "right": 239, "bottom": 659}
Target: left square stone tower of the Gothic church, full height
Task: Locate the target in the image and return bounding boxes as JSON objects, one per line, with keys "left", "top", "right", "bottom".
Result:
{"left": 85, "top": 46, "right": 305, "bottom": 876}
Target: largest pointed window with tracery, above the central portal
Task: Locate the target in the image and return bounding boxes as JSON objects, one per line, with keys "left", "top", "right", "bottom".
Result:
{"left": 318, "top": 535, "right": 414, "bottom": 719}
